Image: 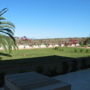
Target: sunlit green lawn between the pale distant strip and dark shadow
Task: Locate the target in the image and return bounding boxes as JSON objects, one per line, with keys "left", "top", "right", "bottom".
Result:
{"left": 1, "top": 47, "right": 90, "bottom": 60}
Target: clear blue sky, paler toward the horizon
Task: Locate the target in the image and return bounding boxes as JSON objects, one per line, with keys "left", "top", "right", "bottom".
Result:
{"left": 0, "top": 0, "right": 90, "bottom": 39}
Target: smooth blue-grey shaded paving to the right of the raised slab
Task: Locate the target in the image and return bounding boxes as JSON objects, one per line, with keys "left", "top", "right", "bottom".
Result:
{"left": 54, "top": 69, "right": 90, "bottom": 90}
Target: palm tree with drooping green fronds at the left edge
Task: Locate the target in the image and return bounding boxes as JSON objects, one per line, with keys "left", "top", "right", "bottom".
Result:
{"left": 0, "top": 8, "right": 16, "bottom": 53}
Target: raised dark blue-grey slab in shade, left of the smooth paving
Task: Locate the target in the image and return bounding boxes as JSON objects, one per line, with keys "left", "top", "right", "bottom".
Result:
{"left": 5, "top": 72, "right": 71, "bottom": 90}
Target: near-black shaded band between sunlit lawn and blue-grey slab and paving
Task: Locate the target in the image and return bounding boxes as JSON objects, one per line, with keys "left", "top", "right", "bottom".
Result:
{"left": 0, "top": 56, "right": 90, "bottom": 86}
